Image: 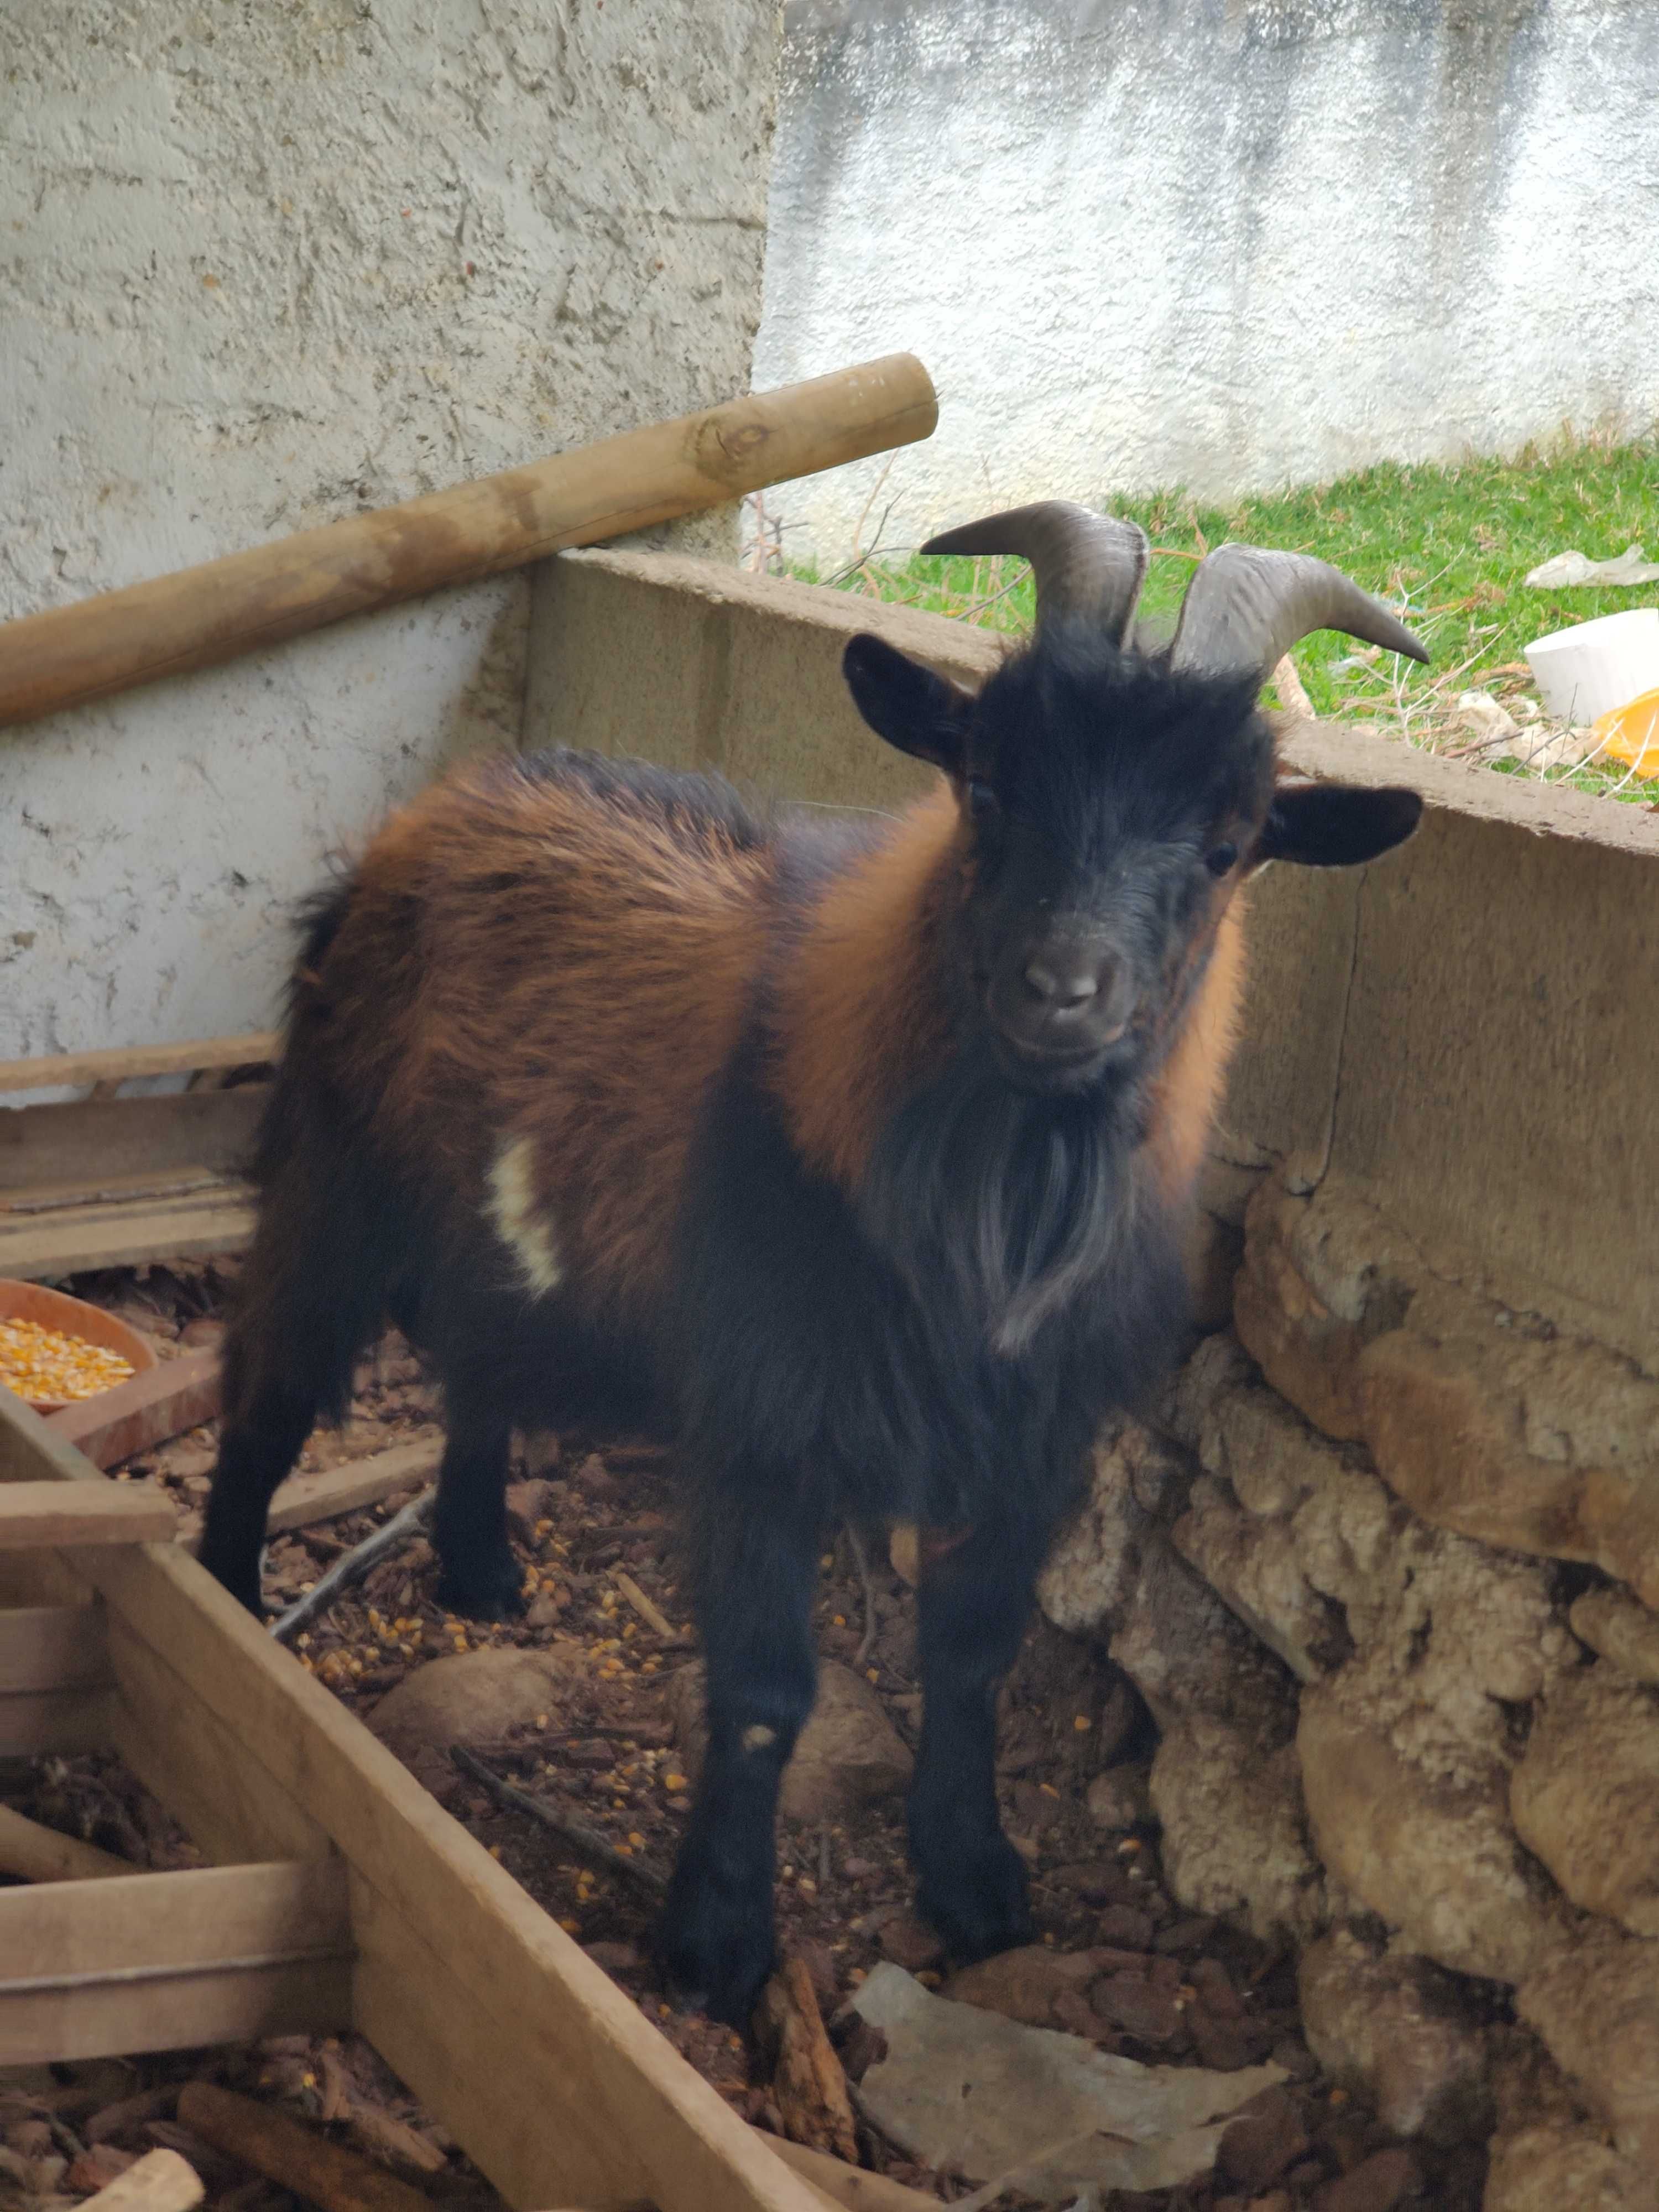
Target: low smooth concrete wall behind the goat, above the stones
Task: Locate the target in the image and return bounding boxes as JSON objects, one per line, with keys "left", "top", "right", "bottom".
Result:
{"left": 524, "top": 551, "right": 1659, "bottom": 1369}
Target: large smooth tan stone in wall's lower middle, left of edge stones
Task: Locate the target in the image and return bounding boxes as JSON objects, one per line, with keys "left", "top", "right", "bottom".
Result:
{"left": 1296, "top": 1677, "right": 1553, "bottom": 1982}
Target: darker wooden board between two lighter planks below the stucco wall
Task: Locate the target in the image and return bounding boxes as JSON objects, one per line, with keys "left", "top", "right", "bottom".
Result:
{"left": 0, "top": 1084, "right": 270, "bottom": 1192}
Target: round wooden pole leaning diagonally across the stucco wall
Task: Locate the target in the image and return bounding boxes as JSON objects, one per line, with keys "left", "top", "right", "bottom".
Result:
{"left": 0, "top": 354, "right": 938, "bottom": 728}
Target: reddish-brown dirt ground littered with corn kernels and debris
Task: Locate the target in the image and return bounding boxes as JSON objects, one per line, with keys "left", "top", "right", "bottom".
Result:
{"left": 0, "top": 1263, "right": 1484, "bottom": 2212}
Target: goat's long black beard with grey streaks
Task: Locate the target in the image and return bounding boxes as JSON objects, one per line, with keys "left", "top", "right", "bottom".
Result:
{"left": 858, "top": 1037, "right": 1139, "bottom": 1358}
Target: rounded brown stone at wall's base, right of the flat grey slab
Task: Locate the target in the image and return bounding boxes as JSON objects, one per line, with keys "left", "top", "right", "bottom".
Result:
{"left": 1298, "top": 1929, "right": 1491, "bottom": 2143}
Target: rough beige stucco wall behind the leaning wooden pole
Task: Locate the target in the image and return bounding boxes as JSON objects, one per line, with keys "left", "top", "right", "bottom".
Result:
{"left": 0, "top": 0, "right": 779, "bottom": 1057}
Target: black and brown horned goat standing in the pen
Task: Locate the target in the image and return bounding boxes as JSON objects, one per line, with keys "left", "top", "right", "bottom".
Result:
{"left": 204, "top": 504, "right": 1422, "bottom": 2020}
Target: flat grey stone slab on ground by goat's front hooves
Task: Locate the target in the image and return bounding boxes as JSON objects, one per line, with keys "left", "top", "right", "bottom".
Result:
{"left": 854, "top": 1964, "right": 1283, "bottom": 2203}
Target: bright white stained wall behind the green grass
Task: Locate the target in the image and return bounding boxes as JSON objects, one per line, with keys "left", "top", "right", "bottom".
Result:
{"left": 757, "top": 0, "right": 1659, "bottom": 557}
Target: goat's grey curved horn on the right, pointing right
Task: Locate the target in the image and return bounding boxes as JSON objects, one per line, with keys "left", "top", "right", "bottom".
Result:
{"left": 1170, "top": 546, "right": 1429, "bottom": 684}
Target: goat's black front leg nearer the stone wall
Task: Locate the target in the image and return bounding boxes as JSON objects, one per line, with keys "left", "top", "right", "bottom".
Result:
{"left": 909, "top": 1524, "right": 1046, "bottom": 1960}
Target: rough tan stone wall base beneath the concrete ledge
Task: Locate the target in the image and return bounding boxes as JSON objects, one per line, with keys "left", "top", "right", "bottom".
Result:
{"left": 1044, "top": 1170, "right": 1659, "bottom": 2212}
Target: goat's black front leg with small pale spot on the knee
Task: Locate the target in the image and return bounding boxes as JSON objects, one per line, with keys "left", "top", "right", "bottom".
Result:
{"left": 657, "top": 1478, "right": 818, "bottom": 2028}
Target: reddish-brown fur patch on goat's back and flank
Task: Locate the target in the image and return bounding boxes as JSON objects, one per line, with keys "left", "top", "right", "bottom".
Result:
{"left": 290, "top": 757, "right": 776, "bottom": 1316}
